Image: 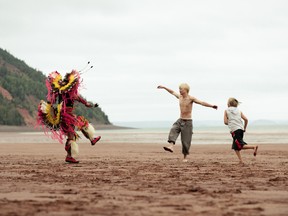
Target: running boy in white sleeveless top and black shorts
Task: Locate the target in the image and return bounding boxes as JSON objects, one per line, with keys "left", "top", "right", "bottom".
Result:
{"left": 224, "top": 98, "right": 258, "bottom": 164}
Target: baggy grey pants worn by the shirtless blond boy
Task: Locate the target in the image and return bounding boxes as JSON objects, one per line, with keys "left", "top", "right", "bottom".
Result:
{"left": 168, "top": 119, "right": 193, "bottom": 155}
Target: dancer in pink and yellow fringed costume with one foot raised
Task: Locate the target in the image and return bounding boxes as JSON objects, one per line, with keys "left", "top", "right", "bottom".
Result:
{"left": 37, "top": 70, "right": 101, "bottom": 163}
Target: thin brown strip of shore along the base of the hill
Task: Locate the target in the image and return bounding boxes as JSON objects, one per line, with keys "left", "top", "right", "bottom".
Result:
{"left": 0, "top": 124, "right": 132, "bottom": 132}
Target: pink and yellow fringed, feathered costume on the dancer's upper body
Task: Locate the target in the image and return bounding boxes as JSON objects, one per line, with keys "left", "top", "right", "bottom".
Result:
{"left": 37, "top": 70, "right": 88, "bottom": 143}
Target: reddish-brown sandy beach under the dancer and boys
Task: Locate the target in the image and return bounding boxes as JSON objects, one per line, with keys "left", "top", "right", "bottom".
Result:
{"left": 0, "top": 132, "right": 288, "bottom": 216}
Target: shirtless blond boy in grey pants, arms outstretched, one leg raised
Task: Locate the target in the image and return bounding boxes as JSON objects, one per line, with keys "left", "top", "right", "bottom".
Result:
{"left": 158, "top": 83, "right": 218, "bottom": 162}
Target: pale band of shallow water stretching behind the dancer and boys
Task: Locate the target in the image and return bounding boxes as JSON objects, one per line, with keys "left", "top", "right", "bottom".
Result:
{"left": 0, "top": 125, "right": 288, "bottom": 145}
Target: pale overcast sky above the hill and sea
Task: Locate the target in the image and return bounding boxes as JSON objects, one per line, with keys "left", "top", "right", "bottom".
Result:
{"left": 0, "top": 0, "right": 288, "bottom": 123}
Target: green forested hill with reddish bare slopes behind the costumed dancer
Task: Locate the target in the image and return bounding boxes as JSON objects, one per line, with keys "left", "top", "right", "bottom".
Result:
{"left": 0, "top": 48, "right": 110, "bottom": 126}
